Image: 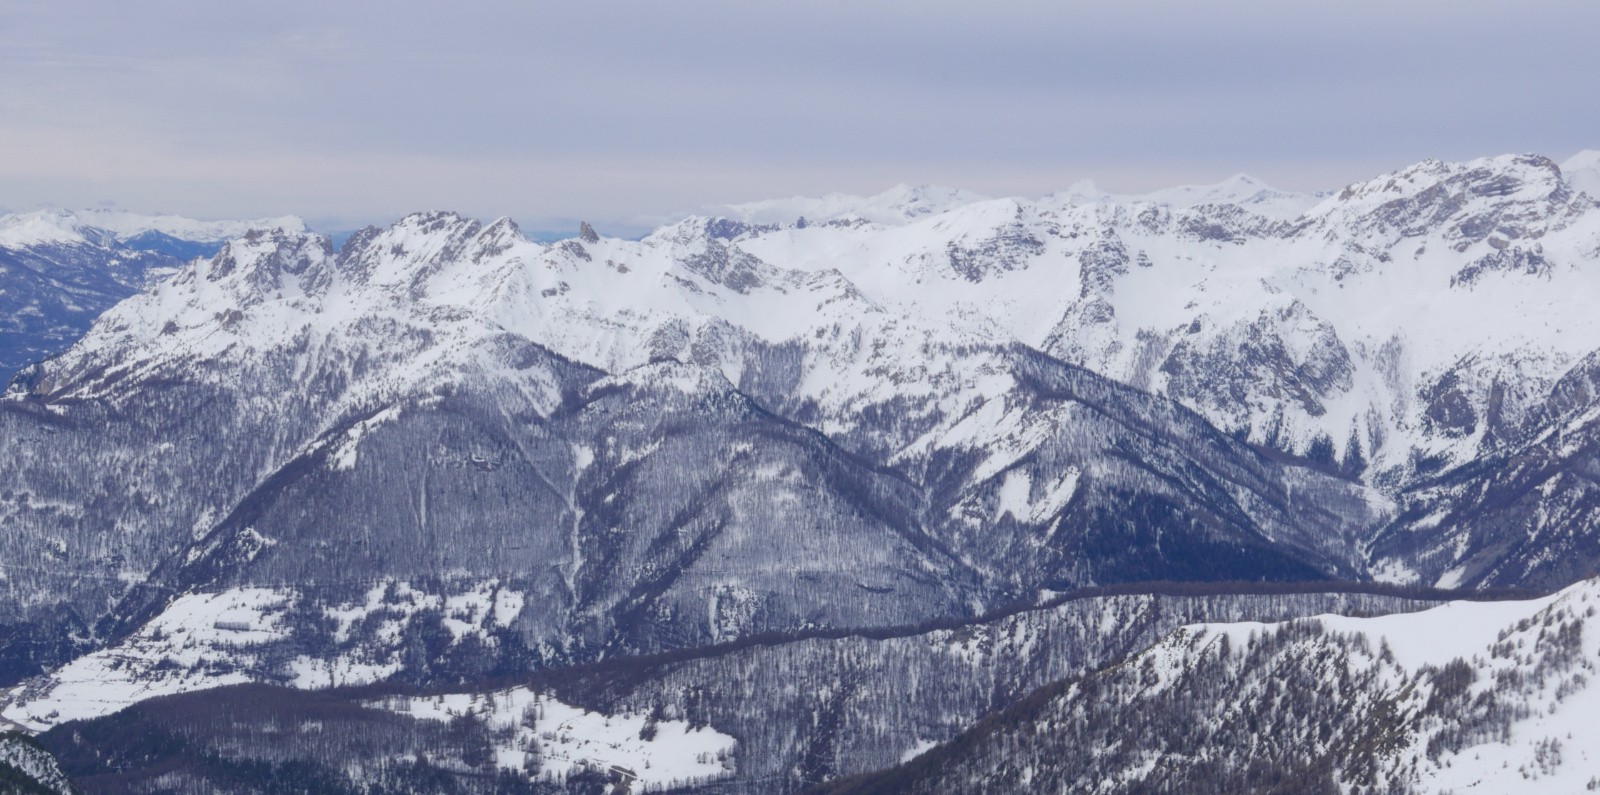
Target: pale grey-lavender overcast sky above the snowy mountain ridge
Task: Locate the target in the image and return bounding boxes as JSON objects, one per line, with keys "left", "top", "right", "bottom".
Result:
{"left": 0, "top": 0, "right": 1600, "bottom": 234}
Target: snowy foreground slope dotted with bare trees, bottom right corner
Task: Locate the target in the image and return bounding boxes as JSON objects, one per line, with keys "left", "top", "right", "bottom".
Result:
{"left": 838, "top": 581, "right": 1600, "bottom": 793}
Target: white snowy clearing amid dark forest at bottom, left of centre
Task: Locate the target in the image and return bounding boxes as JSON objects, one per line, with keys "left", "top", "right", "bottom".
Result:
{"left": 374, "top": 688, "right": 736, "bottom": 787}
